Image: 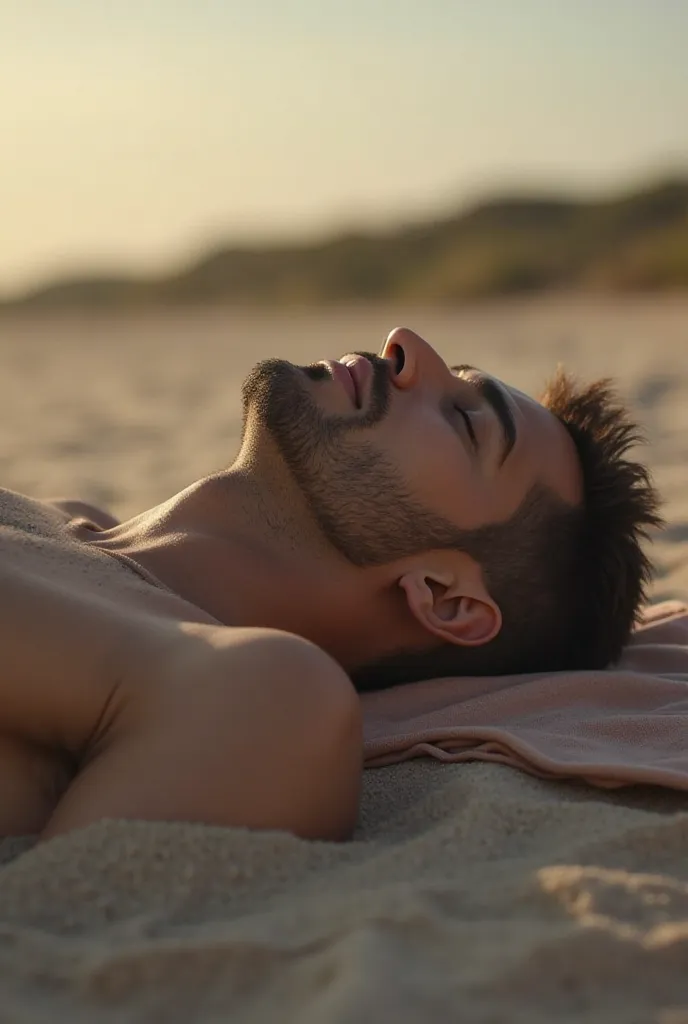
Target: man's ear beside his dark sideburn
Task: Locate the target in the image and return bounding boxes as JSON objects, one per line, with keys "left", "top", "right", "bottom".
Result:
{"left": 398, "top": 565, "right": 502, "bottom": 647}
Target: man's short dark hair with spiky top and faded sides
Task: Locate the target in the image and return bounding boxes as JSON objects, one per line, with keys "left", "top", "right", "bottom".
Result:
{"left": 352, "top": 370, "right": 661, "bottom": 690}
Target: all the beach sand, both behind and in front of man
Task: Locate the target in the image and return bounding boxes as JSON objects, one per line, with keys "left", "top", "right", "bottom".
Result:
{"left": 0, "top": 298, "right": 688, "bottom": 1024}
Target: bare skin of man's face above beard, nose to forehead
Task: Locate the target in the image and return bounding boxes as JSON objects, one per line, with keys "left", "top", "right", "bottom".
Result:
{"left": 350, "top": 328, "right": 581, "bottom": 528}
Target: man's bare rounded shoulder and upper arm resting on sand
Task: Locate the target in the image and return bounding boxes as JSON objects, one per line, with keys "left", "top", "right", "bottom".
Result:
{"left": 42, "top": 629, "right": 362, "bottom": 841}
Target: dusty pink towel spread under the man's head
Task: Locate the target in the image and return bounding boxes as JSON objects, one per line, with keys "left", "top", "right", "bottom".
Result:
{"left": 361, "top": 601, "right": 688, "bottom": 790}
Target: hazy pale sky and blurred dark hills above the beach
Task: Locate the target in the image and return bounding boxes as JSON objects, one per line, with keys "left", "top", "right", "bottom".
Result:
{"left": 0, "top": 0, "right": 688, "bottom": 308}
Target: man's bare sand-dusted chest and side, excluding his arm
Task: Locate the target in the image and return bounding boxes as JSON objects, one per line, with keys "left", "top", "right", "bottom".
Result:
{"left": 0, "top": 489, "right": 219, "bottom": 836}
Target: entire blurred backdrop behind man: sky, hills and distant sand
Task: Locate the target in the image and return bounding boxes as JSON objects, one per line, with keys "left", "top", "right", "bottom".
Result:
{"left": 0, "top": 0, "right": 688, "bottom": 598}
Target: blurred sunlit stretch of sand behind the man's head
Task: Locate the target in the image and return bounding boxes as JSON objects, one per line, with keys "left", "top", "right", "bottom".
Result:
{"left": 0, "top": 297, "right": 688, "bottom": 599}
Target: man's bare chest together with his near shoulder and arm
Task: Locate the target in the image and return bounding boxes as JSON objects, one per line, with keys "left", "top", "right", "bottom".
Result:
{"left": 0, "top": 489, "right": 362, "bottom": 840}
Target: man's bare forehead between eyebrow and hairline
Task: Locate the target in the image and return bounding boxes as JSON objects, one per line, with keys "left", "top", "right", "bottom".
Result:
{"left": 500, "top": 382, "right": 583, "bottom": 504}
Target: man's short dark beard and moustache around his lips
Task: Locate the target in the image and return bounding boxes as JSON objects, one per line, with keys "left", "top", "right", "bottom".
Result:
{"left": 242, "top": 352, "right": 458, "bottom": 567}
